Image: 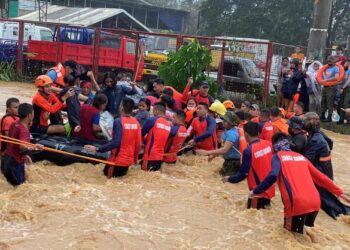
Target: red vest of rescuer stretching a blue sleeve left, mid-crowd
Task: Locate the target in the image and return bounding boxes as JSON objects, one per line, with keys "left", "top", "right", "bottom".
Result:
{"left": 191, "top": 116, "right": 218, "bottom": 150}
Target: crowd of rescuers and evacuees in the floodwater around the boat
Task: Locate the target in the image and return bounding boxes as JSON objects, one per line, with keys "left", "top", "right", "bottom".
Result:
{"left": 1, "top": 61, "right": 350, "bottom": 236}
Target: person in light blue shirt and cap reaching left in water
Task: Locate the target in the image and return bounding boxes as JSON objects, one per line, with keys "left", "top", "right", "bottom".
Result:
{"left": 196, "top": 111, "right": 240, "bottom": 176}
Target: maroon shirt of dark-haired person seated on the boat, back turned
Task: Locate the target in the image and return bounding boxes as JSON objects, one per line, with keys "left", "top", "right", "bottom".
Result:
{"left": 73, "top": 104, "right": 99, "bottom": 140}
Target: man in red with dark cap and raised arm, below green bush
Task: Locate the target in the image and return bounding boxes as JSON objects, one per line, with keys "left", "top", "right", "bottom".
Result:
{"left": 182, "top": 77, "right": 214, "bottom": 107}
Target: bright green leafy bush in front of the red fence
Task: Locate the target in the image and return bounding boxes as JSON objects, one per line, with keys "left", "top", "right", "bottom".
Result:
{"left": 159, "top": 40, "right": 211, "bottom": 92}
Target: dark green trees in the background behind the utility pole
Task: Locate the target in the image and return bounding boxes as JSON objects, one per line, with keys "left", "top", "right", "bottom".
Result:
{"left": 200, "top": 0, "right": 350, "bottom": 46}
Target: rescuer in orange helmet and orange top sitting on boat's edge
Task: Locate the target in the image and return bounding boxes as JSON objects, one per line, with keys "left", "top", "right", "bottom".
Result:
{"left": 30, "top": 75, "right": 75, "bottom": 134}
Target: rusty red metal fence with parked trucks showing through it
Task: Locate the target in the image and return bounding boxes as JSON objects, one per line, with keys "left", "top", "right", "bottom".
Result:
{"left": 0, "top": 19, "right": 275, "bottom": 104}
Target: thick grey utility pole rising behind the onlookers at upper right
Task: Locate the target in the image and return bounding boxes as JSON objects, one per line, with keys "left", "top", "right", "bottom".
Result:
{"left": 307, "top": 0, "right": 333, "bottom": 61}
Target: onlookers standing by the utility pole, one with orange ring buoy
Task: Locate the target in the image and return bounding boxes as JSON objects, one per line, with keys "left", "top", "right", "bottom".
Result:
{"left": 276, "top": 46, "right": 350, "bottom": 124}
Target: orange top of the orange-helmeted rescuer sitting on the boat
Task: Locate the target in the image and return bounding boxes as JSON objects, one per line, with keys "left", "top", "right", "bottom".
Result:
{"left": 32, "top": 92, "right": 63, "bottom": 127}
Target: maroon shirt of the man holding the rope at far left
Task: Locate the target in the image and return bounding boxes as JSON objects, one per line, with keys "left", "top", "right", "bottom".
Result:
{"left": 5, "top": 122, "right": 30, "bottom": 164}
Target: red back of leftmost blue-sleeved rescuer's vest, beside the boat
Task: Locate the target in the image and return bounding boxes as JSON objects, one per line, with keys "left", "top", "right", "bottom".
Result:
{"left": 108, "top": 117, "right": 141, "bottom": 176}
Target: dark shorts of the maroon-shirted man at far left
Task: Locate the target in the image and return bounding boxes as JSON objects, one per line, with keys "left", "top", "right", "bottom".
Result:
{"left": 1, "top": 156, "right": 26, "bottom": 186}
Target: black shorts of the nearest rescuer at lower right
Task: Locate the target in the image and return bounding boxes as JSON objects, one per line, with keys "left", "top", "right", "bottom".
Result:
{"left": 284, "top": 211, "right": 318, "bottom": 234}
